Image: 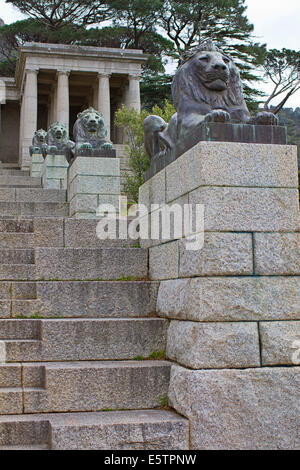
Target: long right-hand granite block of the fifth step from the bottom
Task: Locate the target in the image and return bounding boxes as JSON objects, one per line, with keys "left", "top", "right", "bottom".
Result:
{"left": 35, "top": 248, "right": 148, "bottom": 280}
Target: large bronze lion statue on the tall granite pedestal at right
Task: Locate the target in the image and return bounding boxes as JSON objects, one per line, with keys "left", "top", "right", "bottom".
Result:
{"left": 144, "top": 40, "right": 278, "bottom": 159}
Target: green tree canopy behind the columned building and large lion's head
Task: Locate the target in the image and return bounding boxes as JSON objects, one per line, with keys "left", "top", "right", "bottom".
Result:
{"left": 0, "top": 0, "right": 284, "bottom": 110}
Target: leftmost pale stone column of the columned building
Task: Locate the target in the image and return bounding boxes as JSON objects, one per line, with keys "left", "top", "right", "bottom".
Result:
{"left": 20, "top": 69, "right": 38, "bottom": 168}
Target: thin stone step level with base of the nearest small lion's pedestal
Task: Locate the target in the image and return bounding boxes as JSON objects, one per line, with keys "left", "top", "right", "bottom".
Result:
{"left": 0, "top": 201, "right": 69, "bottom": 217}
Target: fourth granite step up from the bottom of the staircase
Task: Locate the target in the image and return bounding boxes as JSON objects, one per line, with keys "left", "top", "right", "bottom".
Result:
{"left": 8, "top": 281, "right": 159, "bottom": 318}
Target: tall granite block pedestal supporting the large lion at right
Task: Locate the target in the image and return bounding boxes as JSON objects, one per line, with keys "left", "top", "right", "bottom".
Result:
{"left": 140, "top": 142, "right": 300, "bottom": 449}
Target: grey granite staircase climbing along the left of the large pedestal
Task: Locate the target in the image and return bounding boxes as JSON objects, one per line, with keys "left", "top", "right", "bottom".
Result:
{"left": 0, "top": 168, "right": 189, "bottom": 450}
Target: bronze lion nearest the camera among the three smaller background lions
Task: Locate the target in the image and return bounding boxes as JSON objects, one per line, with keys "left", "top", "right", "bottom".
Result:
{"left": 73, "top": 108, "right": 113, "bottom": 155}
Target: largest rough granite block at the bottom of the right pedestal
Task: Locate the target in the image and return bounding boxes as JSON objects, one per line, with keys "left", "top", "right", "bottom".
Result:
{"left": 169, "top": 366, "right": 300, "bottom": 450}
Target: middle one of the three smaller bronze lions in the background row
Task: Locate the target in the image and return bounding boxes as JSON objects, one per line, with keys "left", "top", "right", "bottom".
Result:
{"left": 46, "top": 122, "right": 75, "bottom": 162}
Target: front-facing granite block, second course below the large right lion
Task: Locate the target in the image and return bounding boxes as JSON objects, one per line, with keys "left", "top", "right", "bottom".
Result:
{"left": 189, "top": 187, "right": 300, "bottom": 232}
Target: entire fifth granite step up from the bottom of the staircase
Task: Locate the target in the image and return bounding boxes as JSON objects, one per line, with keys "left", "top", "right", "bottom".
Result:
{"left": 0, "top": 248, "right": 148, "bottom": 281}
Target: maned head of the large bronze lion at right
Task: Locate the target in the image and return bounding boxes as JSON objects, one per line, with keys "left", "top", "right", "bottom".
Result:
{"left": 172, "top": 40, "right": 247, "bottom": 117}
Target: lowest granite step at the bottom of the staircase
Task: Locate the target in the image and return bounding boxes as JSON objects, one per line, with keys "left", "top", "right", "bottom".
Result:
{"left": 0, "top": 410, "right": 189, "bottom": 450}
